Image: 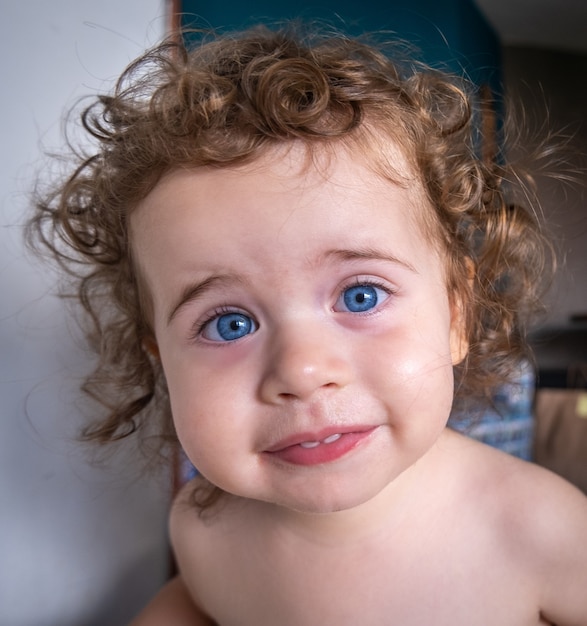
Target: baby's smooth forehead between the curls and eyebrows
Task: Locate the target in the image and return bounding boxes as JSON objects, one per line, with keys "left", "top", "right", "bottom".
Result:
{"left": 130, "top": 144, "right": 435, "bottom": 308}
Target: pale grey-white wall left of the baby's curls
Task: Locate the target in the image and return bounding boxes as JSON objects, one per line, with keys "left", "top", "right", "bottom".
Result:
{"left": 0, "top": 0, "right": 172, "bottom": 626}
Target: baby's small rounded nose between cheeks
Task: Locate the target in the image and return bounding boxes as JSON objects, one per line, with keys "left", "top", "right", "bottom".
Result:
{"left": 260, "top": 324, "right": 352, "bottom": 404}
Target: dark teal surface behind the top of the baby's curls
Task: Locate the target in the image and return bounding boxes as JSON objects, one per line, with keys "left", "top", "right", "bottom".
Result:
{"left": 179, "top": 0, "right": 500, "bottom": 85}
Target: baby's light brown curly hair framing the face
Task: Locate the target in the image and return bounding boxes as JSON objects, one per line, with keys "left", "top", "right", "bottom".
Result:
{"left": 29, "top": 27, "right": 548, "bottom": 488}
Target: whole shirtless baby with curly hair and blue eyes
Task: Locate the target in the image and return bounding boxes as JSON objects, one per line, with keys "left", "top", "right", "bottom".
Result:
{"left": 33, "top": 23, "right": 587, "bottom": 626}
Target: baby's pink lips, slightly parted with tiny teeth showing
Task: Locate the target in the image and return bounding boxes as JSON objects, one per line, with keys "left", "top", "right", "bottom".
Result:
{"left": 264, "top": 426, "right": 377, "bottom": 465}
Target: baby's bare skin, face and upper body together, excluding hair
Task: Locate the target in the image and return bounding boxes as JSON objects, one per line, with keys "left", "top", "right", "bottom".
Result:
{"left": 131, "top": 144, "right": 587, "bottom": 626}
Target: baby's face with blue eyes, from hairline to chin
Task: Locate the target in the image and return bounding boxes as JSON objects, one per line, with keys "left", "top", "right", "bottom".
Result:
{"left": 131, "top": 146, "right": 463, "bottom": 512}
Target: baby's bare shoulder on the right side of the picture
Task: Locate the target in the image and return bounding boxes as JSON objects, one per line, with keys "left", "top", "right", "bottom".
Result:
{"left": 453, "top": 428, "right": 587, "bottom": 626}
